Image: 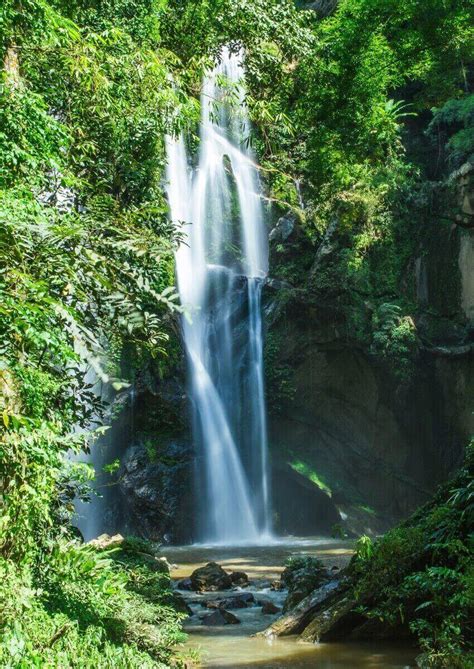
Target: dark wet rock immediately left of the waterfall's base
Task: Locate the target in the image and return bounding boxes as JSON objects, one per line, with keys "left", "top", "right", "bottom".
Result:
{"left": 119, "top": 442, "right": 192, "bottom": 542}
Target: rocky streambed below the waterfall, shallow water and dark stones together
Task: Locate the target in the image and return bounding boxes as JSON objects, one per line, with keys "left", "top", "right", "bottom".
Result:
{"left": 166, "top": 540, "right": 416, "bottom": 669}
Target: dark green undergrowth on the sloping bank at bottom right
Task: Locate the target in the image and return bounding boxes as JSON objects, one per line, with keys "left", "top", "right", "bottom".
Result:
{"left": 350, "top": 443, "right": 474, "bottom": 669}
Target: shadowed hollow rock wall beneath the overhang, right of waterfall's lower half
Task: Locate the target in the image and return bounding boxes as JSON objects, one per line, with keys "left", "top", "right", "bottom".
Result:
{"left": 269, "top": 291, "right": 474, "bottom": 535}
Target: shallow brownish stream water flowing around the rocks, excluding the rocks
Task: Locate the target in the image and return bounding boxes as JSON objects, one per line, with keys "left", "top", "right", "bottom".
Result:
{"left": 163, "top": 539, "right": 416, "bottom": 669}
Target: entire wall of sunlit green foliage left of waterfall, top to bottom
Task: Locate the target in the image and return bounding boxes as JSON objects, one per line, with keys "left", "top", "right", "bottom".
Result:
{"left": 0, "top": 0, "right": 193, "bottom": 668}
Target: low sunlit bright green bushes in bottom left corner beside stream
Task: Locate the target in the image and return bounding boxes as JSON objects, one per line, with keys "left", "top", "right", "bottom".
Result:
{"left": 0, "top": 539, "right": 186, "bottom": 669}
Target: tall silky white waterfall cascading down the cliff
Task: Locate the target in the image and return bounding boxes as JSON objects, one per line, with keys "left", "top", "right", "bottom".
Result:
{"left": 167, "top": 48, "right": 271, "bottom": 545}
